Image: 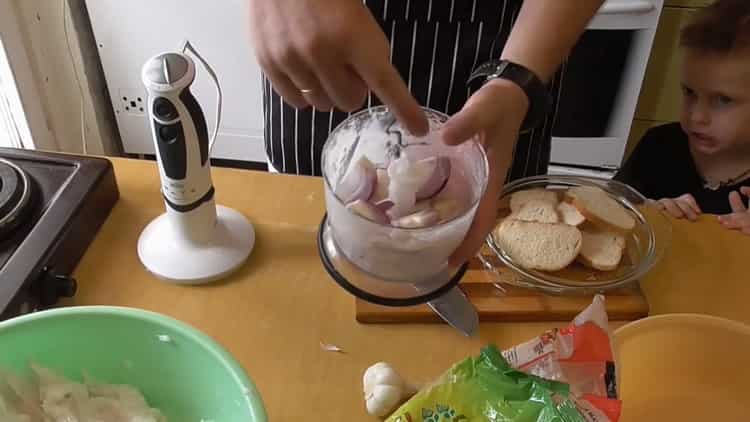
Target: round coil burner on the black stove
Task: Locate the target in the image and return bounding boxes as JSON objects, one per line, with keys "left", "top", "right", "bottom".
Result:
{"left": 0, "top": 158, "right": 32, "bottom": 237}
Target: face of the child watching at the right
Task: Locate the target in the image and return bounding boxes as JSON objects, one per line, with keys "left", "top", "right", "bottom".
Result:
{"left": 681, "top": 49, "right": 750, "bottom": 155}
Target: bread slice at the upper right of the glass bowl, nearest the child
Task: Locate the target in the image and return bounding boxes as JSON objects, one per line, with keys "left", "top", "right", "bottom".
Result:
{"left": 565, "top": 186, "right": 635, "bottom": 234}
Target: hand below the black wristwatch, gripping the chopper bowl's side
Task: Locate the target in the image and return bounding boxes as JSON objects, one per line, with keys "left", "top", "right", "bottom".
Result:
{"left": 443, "top": 79, "right": 529, "bottom": 266}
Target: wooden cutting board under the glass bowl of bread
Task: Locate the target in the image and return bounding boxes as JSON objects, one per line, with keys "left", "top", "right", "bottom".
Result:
{"left": 356, "top": 254, "right": 649, "bottom": 324}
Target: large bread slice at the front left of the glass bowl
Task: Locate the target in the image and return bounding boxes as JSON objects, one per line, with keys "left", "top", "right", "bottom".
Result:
{"left": 493, "top": 219, "right": 582, "bottom": 271}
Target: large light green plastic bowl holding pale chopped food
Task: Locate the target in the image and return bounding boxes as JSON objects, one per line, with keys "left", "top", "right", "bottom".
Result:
{"left": 0, "top": 306, "right": 267, "bottom": 422}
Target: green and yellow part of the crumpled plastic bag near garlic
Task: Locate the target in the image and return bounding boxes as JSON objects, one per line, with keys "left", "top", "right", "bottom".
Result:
{"left": 387, "top": 346, "right": 585, "bottom": 422}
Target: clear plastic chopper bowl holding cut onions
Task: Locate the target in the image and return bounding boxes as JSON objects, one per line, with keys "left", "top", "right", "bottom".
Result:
{"left": 322, "top": 106, "right": 489, "bottom": 285}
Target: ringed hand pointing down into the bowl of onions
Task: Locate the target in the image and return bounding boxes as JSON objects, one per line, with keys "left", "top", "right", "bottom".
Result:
{"left": 250, "top": 0, "right": 428, "bottom": 135}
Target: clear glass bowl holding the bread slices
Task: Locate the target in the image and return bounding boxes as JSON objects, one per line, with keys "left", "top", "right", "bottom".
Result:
{"left": 486, "top": 176, "right": 672, "bottom": 294}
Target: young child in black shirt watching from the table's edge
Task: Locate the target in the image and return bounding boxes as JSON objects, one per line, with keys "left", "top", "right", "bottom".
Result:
{"left": 615, "top": 0, "right": 750, "bottom": 235}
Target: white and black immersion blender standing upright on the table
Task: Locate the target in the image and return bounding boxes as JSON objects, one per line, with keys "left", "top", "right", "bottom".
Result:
{"left": 138, "top": 43, "right": 255, "bottom": 284}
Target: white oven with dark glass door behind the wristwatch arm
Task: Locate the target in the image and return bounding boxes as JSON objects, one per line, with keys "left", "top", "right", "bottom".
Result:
{"left": 550, "top": 0, "right": 664, "bottom": 177}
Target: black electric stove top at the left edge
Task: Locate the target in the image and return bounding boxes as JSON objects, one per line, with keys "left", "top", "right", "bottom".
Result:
{"left": 0, "top": 148, "right": 119, "bottom": 320}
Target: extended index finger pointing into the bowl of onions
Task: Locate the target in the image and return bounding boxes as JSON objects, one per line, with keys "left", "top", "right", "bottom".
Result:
{"left": 352, "top": 54, "right": 430, "bottom": 136}
